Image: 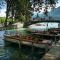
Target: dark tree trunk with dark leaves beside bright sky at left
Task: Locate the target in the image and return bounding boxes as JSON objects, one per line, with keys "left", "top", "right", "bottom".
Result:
{"left": 5, "top": 0, "right": 15, "bottom": 26}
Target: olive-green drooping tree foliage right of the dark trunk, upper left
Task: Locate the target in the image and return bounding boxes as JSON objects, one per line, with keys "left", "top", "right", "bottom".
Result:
{"left": 16, "top": 0, "right": 31, "bottom": 22}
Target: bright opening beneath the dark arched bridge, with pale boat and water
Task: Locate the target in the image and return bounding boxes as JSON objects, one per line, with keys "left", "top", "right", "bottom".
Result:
{"left": 28, "top": 22, "right": 58, "bottom": 32}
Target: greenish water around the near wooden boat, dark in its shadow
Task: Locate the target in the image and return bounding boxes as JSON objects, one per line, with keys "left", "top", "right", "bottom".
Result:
{"left": 0, "top": 29, "right": 45, "bottom": 60}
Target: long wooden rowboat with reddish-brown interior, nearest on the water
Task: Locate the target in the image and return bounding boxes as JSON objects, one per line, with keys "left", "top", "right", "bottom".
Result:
{"left": 5, "top": 35, "right": 51, "bottom": 49}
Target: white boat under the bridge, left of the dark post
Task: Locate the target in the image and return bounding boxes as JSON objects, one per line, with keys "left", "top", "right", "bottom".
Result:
{"left": 28, "top": 23, "right": 47, "bottom": 32}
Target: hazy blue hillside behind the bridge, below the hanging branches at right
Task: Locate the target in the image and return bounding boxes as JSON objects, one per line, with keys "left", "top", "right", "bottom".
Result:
{"left": 32, "top": 7, "right": 60, "bottom": 20}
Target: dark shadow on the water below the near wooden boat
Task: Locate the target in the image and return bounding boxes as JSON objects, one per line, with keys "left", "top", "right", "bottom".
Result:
{"left": 5, "top": 42, "right": 45, "bottom": 60}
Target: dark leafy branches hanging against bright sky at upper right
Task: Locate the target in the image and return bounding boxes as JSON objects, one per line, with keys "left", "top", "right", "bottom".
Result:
{"left": 33, "top": 0, "right": 58, "bottom": 15}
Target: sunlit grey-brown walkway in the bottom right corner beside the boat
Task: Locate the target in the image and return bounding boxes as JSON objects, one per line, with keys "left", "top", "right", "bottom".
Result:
{"left": 41, "top": 40, "right": 60, "bottom": 60}
